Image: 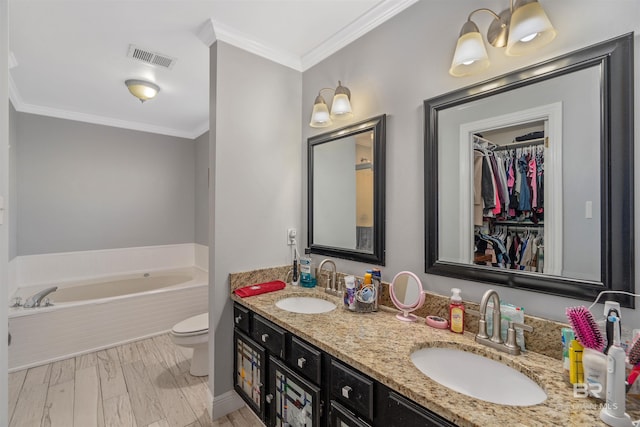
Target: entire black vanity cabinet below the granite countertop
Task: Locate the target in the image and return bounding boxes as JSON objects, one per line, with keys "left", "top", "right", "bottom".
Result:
{"left": 234, "top": 303, "right": 455, "bottom": 427}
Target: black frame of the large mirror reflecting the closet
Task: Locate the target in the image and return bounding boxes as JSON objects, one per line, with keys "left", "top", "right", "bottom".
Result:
{"left": 424, "top": 33, "right": 635, "bottom": 308}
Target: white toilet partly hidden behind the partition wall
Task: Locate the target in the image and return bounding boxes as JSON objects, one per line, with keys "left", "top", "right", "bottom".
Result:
{"left": 170, "top": 313, "right": 209, "bottom": 377}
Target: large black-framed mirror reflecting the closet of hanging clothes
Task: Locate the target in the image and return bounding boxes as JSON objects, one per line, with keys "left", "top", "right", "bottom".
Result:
{"left": 424, "top": 34, "right": 634, "bottom": 307}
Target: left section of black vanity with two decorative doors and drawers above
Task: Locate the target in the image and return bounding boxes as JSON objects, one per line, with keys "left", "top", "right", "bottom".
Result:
{"left": 234, "top": 304, "right": 325, "bottom": 427}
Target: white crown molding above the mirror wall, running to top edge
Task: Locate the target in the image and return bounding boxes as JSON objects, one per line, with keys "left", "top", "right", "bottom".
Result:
{"left": 300, "top": 0, "right": 418, "bottom": 71}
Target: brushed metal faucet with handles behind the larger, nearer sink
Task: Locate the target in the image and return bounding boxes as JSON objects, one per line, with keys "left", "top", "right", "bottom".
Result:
{"left": 467, "top": 289, "right": 533, "bottom": 355}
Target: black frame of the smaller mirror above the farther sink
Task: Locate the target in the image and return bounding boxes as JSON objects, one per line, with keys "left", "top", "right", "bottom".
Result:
{"left": 307, "top": 114, "right": 387, "bottom": 265}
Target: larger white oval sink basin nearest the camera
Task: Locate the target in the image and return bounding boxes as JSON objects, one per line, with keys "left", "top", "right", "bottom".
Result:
{"left": 411, "top": 347, "right": 547, "bottom": 406}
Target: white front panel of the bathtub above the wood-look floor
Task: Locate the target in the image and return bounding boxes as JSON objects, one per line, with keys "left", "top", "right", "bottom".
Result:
{"left": 9, "top": 267, "right": 209, "bottom": 372}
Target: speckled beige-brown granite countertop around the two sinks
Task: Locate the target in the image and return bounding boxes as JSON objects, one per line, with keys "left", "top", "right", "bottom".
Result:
{"left": 231, "top": 282, "right": 640, "bottom": 426}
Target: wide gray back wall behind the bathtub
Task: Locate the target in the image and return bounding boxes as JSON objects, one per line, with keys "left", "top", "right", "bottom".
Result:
{"left": 17, "top": 113, "right": 195, "bottom": 255}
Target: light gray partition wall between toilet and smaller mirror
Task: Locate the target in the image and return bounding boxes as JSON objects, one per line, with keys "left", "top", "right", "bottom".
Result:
{"left": 209, "top": 41, "right": 302, "bottom": 396}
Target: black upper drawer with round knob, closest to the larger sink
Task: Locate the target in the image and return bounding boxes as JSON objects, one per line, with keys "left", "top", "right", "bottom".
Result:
{"left": 329, "top": 359, "right": 373, "bottom": 421}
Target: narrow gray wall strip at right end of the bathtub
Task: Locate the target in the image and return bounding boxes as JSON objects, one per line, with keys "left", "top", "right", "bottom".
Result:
{"left": 194, "top": 131, "right": 209, "bottom": 246}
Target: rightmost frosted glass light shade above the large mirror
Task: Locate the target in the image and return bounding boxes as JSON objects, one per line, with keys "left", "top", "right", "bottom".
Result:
{"left": 506, "top": 0, "right": 556, "bottom": 56}
